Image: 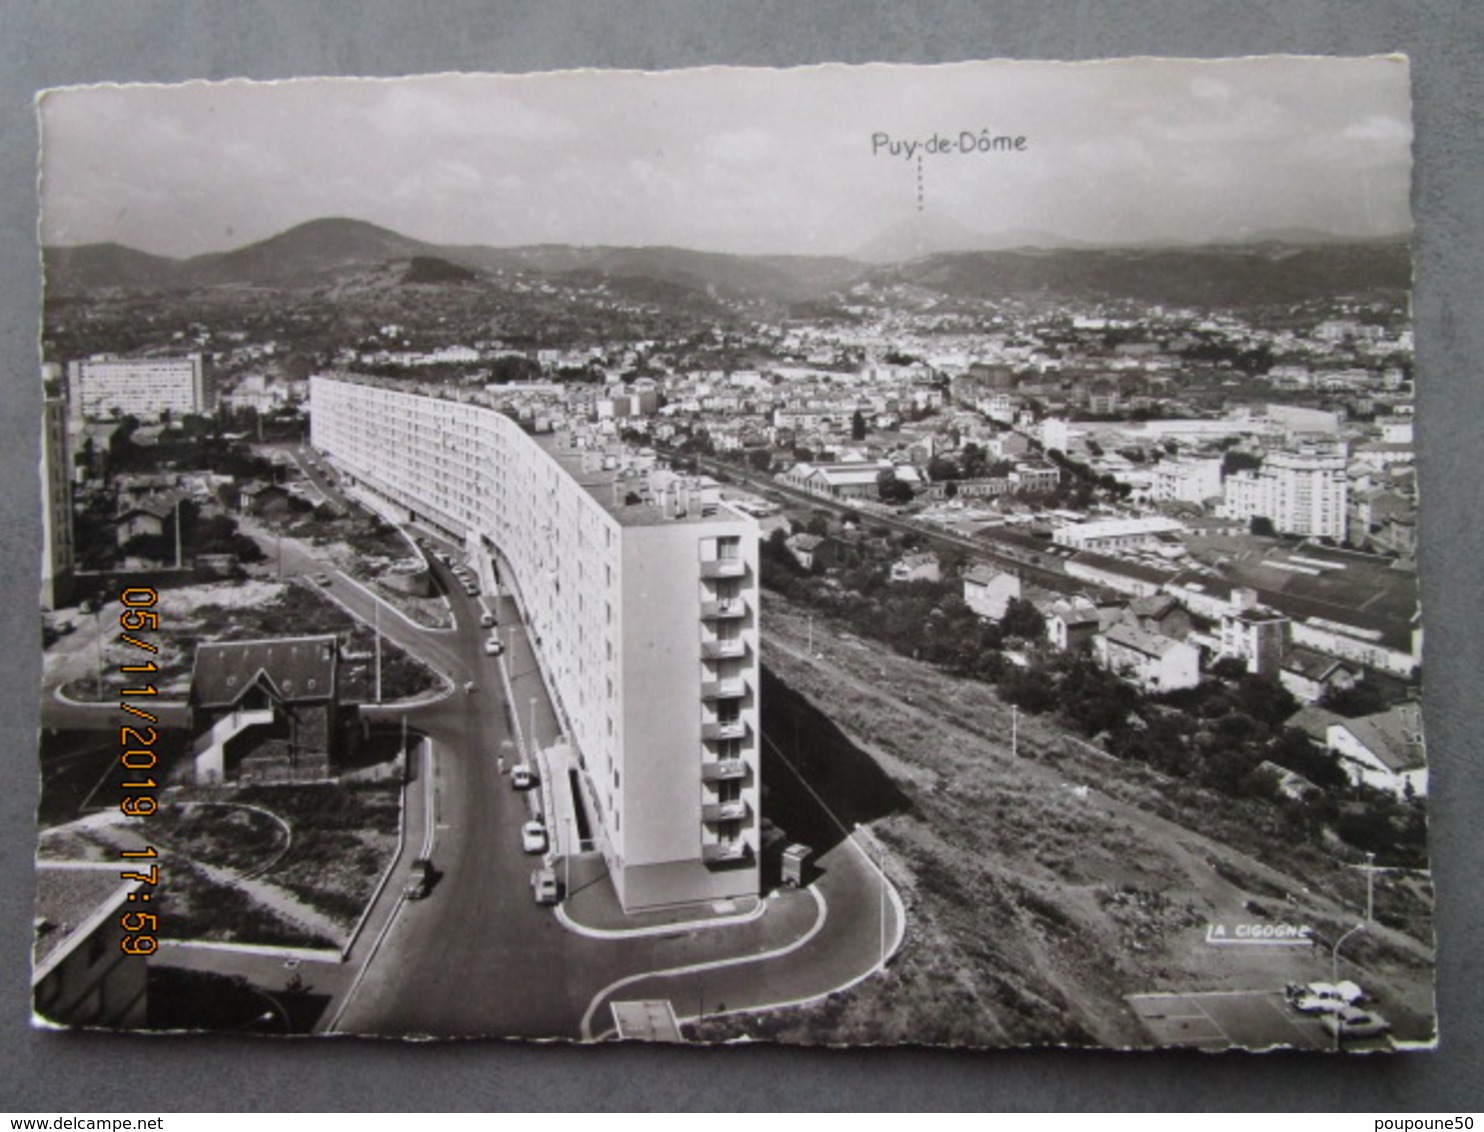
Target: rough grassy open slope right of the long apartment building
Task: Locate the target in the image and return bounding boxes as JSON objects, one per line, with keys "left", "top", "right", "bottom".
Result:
{"left": 700, "top": 595, "right": 1432, "bottom": 1047}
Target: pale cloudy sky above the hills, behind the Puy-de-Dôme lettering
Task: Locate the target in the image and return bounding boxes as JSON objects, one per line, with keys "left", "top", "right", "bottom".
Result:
{"left": 39, "top": 56, "right": 1411, "bottom": 257}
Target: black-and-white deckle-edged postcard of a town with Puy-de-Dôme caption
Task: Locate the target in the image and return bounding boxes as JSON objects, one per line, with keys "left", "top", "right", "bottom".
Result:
{"left": 33, "top": 56, "right": 1435, "bottom": 1052}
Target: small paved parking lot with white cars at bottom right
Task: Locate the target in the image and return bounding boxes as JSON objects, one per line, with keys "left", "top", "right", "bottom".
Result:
{"left": 1128, "top": 991, "right": 1334, "bottom": 1049}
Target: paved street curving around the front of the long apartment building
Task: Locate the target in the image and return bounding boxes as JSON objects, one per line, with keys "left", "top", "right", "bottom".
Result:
{"left": 43, "top": 483, "right": 901, "bottom": 1039}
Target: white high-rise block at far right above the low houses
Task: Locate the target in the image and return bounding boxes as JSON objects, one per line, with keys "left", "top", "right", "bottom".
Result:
{"left": 1221, "top": 445, "right": 1349, "bottom": 539}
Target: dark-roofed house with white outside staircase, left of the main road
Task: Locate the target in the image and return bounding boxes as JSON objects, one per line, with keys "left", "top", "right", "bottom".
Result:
{"left": 190, "top": 635, "right": 340, "bottom": 785}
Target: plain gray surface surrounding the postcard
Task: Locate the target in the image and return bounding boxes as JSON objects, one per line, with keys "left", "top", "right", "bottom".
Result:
{"left": 0, "top": 0, "right": 1484, "bottom": 1113}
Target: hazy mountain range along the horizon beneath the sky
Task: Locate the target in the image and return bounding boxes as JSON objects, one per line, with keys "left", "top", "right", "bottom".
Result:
{"left": 43, "top": 218, "right": 1411, "bottom": 306}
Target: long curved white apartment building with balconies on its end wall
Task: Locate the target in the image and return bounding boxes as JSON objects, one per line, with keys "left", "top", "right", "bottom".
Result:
{"left": 310, "top": 377, "right": 760, "bottom": 911}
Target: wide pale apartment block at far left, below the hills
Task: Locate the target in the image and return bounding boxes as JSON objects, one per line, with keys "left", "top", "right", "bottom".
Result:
{"left": 67, "top": 353, "right": 217, "bottom": 420}
